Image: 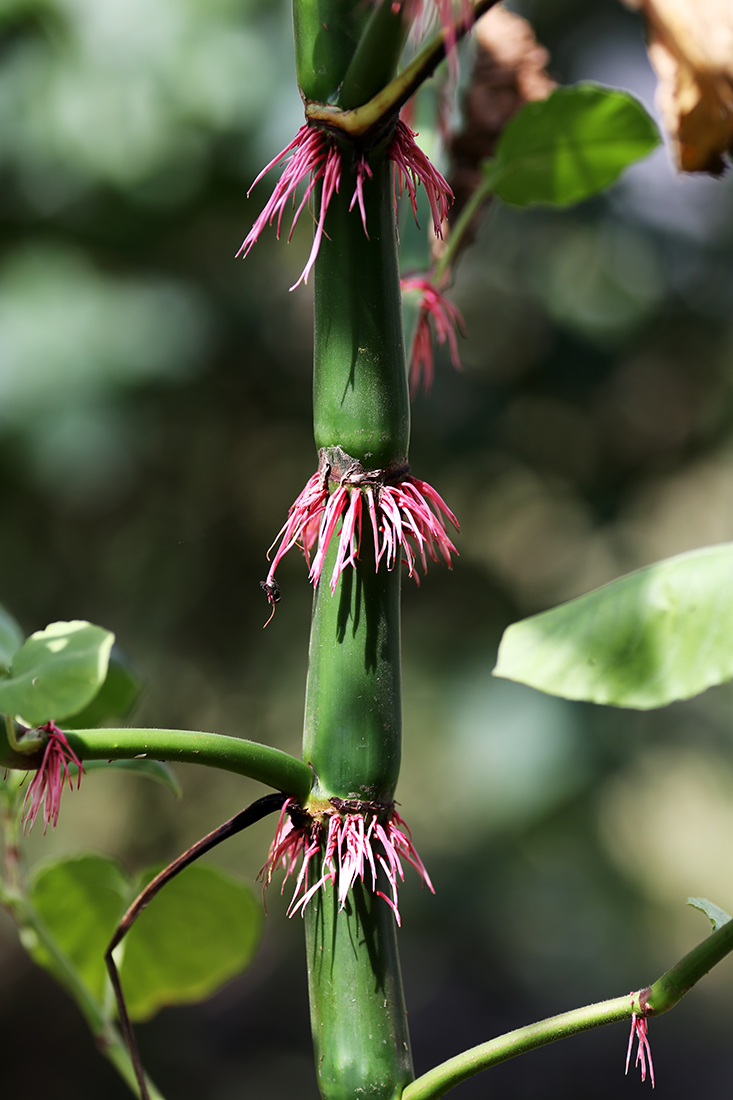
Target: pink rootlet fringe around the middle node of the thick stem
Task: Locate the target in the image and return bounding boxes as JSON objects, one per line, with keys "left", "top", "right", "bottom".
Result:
{"left": 264, "top": 473, "right": 459, "bottom": 602}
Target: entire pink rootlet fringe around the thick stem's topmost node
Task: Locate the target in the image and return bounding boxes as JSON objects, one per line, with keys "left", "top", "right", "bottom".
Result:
{"left": 237, "top": 122, "right": 453, "bottom": 290}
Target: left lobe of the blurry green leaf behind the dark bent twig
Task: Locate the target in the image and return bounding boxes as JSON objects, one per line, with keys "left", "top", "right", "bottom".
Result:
{"left": 31, "top": 854, "right": 131, "bottom": 1003}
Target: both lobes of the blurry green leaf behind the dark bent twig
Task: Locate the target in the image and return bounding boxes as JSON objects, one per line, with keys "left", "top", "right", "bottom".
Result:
{"left": 28, "top": 854, "right": 262, "bottom": 1020}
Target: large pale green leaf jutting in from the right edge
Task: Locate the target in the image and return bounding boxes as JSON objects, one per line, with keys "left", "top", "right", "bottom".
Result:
{"left": 494, "top": 542, "right": 733, "bottom": 711}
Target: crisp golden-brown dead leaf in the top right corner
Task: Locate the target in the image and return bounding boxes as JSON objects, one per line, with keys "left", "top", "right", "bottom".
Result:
{"left": 624, "top": 0, "right": 733, "bottom": 175}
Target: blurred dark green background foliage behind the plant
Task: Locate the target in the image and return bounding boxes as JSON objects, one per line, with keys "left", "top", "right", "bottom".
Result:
{"left": 0, "top": 0, "right": 733, "bottom": 1100}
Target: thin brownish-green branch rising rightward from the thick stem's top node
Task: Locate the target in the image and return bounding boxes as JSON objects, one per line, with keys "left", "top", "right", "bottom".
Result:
{"left": 306, "top": 0, "right": 497, "bottom": 142}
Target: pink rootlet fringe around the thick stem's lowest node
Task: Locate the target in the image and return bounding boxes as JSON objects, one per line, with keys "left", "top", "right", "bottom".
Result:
{"left": 260, "top": 799, "right": 435, "bottom": 924}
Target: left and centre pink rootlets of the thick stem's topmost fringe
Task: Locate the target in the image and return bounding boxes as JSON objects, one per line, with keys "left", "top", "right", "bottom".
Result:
{"left": 237, "top": 123, "right": 372, "bottom": 290}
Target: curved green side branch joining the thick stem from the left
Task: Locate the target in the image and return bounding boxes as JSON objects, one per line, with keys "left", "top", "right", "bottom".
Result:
{"left": 0, "top": 729, "right": 313, "bottom": 801}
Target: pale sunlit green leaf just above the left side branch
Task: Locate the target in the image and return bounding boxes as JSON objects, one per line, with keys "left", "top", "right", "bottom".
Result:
{"left": 0, "top": 622, "right": 114, "bottom": 726}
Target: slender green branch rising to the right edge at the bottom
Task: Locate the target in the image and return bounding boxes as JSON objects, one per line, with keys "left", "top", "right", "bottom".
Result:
{"left": 402, "top": 921, "right": 733, "bottom": 1100}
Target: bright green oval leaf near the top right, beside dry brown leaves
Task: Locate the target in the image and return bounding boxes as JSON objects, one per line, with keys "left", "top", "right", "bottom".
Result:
{"left": 484, "top": 84, "right": 660, "bottom": 207}
